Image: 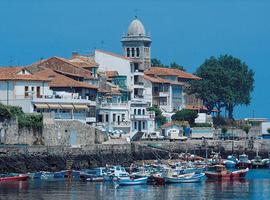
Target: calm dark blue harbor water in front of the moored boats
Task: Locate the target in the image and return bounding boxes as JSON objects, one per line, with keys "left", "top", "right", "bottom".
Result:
{"left": 0, "top": 169, "right": 270, "bottom": 200}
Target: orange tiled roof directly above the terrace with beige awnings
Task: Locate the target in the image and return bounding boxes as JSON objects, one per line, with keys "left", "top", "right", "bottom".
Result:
{"left": 32, "top": 68, "right": 97, "bottom": 89}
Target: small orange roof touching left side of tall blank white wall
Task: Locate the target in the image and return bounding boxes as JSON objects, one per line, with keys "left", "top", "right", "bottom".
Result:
{"left": 69, "top": 55, "right": 98, "bottom": 69}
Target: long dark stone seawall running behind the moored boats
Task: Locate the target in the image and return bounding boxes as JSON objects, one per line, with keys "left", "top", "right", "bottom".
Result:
{"left": 0, "top": 140, "right": 270, "bottom": 173}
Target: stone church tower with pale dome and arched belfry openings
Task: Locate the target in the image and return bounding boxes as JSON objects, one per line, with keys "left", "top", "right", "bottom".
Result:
{"left": 121, "top": 17, "right": 152, "bottom": 71}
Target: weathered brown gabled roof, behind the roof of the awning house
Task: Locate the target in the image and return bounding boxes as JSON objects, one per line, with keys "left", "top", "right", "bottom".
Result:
{"left": 31, "top": 56, "right": 93, "bottom": 79}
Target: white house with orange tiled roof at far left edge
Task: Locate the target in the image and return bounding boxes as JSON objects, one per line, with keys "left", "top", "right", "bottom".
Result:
{"left": 0, "top": 67, "right": 52, "bottom": 113}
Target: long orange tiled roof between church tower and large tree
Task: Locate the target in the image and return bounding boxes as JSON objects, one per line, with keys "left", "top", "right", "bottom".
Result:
{"left": 144, "top": 67, "right": 201, "bottom": 80}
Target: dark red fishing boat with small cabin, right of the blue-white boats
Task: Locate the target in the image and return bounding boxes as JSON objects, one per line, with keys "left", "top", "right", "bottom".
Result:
{"left": 205, "top": 165, "right": 249, "bottom": 179}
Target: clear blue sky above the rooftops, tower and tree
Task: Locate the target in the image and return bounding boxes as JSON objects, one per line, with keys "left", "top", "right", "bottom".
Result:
{"left": 0, "top": 0, "right": 270, "bottom": 118}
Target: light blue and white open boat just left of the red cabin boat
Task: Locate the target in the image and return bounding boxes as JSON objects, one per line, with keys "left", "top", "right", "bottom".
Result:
{"left": 164, "top": 173, "right": 205, "bottom": 183}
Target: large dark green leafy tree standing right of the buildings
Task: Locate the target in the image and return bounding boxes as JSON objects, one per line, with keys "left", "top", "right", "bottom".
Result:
{"left": 189, "top": 55, "right": 254, "bottom": 119}
